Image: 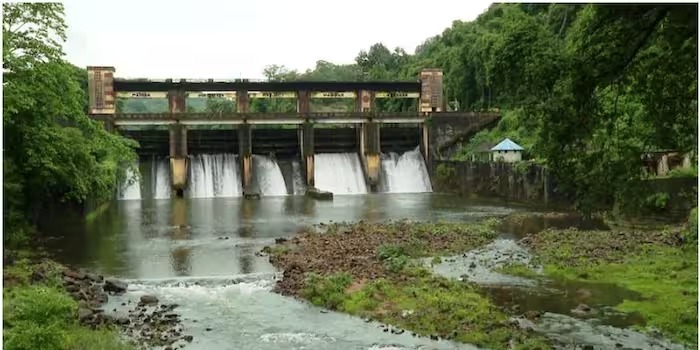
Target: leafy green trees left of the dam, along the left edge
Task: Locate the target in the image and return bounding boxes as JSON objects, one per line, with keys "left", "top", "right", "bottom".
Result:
{"left": 3, "top": 3, "right": 136, "bottom": 243}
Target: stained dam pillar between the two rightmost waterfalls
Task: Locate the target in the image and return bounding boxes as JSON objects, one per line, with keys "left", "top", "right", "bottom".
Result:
{"left": 355, "top": 90, "right": 381, "bottom": 192}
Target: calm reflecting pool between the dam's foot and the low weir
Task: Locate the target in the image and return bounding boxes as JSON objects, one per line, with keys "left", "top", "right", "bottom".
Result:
{"left": 43, "top": 194, "right": 516, "bottom": 278}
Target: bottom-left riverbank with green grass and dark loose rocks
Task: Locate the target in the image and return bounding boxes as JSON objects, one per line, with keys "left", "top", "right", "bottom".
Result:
{"left": 3, "top": 252, "right": 193, "bottom": 350}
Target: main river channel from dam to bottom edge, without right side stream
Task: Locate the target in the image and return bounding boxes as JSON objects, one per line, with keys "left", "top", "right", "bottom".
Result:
{"left": 43, "top": 193, "right": 524, "bottom": 349}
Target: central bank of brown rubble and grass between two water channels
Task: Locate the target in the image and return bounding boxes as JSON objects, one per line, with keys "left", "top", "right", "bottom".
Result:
{"left": 267, "top": 220, "right": 549, "bottom": 349}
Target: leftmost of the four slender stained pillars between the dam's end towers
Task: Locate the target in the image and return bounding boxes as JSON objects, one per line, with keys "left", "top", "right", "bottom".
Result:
{"left": 168, "top": 90, "right": 188, "bottom": 197}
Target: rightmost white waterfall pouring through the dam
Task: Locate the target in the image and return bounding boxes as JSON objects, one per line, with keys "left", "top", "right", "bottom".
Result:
{"left": 378, "top": 147, "right": 433, "bottom": 193}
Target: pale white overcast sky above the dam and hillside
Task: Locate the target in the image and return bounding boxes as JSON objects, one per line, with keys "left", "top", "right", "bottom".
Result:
{"left": 64, "top": 0, "right": 491, "bottom": 79}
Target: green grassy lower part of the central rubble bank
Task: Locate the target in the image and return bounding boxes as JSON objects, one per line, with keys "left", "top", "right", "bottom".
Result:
{"left": 303, "top": 266, "right": 549, "bottom": 349}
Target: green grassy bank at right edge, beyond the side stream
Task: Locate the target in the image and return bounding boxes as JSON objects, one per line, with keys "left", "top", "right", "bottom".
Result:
{"left": 507, "top": 226, "right": 698, "bottom": 348}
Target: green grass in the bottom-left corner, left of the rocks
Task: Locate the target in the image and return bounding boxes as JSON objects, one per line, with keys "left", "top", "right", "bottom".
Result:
{"left": 3, "top": 254, "right": 132, "bottom": 350}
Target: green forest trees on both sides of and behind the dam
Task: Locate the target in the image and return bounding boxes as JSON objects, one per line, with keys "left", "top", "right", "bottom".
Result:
{"left": 3, "top": 4, "right": 698, "bottom": 245}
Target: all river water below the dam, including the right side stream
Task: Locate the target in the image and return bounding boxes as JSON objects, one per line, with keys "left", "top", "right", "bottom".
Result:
{"left": 39, "top": 193, "right": 682, "bottom": 349}
